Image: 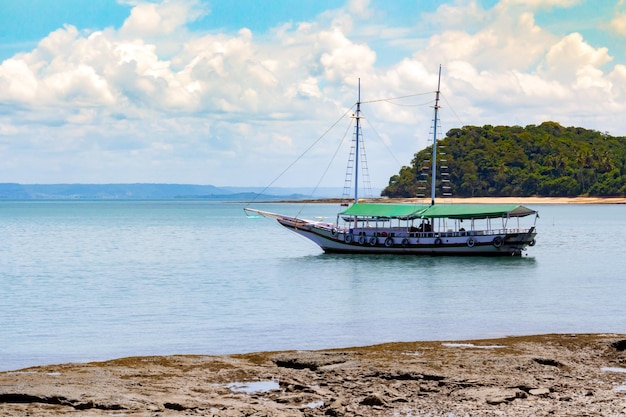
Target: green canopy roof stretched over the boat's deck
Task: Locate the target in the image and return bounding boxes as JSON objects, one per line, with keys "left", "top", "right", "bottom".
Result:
{"left": 341, "top": 203, "right": 535, "bottom": 219}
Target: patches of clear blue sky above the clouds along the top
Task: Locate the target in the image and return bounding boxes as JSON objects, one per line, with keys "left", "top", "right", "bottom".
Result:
{"left": 0, "top": 0, "right": 626, "bottom": 63}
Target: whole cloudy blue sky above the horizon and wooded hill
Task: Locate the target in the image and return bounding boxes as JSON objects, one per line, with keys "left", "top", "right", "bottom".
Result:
{"left": 0, "top": 0, "right": 626, "bottom": 188}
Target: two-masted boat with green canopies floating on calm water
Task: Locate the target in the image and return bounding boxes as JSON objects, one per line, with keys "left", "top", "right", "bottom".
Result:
{"left": 244, "top": 67, "right": 538, "bottom": 256}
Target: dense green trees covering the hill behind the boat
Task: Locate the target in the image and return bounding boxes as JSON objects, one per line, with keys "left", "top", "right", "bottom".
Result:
{"left": 382, "top": 122, "right": 626, "bottom": 197}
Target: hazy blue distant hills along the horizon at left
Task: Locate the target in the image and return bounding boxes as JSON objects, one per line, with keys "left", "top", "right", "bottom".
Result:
{"left": 0, "top": 183, "right": 342, "bottom": 201}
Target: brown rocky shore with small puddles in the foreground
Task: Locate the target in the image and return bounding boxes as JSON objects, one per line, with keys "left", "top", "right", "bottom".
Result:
{"left": 0, "top": 334, "right": 626, "bottom": 417}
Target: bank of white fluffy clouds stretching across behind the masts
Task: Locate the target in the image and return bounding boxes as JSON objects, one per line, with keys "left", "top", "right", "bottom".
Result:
{"left": 0, "top": 0, "right": 626, "bottom": 186}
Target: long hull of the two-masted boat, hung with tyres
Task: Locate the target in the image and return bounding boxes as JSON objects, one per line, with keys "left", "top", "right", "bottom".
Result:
{"left": 277, "top": 218, "right": 537, "bottom": 256}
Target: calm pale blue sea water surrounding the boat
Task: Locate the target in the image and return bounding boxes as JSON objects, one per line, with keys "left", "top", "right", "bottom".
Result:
{"left": 0, "top": 201, "right": 626, "bottom": 370}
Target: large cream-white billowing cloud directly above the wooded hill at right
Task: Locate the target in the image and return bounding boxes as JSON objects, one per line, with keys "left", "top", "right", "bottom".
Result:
{"left": 400, "top": 0, "right": 624, "bottom": 129}
